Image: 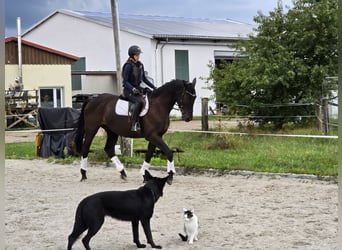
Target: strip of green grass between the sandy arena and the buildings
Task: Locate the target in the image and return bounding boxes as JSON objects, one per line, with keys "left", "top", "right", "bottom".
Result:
{"left": 5, "top": 129, "right": 338, "bottom": 176}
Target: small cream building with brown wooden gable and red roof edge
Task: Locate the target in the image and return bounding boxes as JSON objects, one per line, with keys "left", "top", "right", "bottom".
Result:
{"left": 5, "top": 37, "right": 79, "bottom": 107}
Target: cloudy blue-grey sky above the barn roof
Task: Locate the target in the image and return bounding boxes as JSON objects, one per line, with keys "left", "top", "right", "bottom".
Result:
{"left": 5, "top": 0, "right": 292, "bottom": 37}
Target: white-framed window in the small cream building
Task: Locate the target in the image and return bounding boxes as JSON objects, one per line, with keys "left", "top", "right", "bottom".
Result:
{"left": 39, "top": 88, "right": 64, "bottom": 108}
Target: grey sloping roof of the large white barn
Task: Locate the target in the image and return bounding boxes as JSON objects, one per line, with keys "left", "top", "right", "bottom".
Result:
{"left": 24, "top": 10, "right": 255, "bottom": 40}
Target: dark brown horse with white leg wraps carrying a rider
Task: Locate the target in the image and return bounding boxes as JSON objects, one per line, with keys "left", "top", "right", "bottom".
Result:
{"left": 74, "top": 78, "right": 196, "bottom": 181}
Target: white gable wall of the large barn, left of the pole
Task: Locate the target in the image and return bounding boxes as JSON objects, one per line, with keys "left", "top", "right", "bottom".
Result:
{"left": 23, "top": 13, "right": 115, "bottom": 71}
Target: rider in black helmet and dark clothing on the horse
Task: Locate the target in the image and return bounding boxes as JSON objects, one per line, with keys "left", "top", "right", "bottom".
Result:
{"left": 122, "top": 45, "right": 156, "bottom": 131}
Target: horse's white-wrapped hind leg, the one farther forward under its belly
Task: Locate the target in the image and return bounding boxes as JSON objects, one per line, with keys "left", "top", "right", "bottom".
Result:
{"left": 104, "top": 129, "right": 127, "bottom": 180}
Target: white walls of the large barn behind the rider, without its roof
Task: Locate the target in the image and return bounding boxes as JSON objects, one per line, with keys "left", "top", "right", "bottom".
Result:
{"left": 24, "top": 13, "right": 239, "bottom": 116}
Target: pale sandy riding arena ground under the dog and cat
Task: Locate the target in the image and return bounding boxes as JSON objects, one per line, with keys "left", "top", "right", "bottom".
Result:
{"left": 5, "top": 160, "right": 338, "bottom": 250}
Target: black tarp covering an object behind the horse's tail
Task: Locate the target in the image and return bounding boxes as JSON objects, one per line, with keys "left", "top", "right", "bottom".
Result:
{"left": 38, "top": 108, "right": 80, "bottom": 158}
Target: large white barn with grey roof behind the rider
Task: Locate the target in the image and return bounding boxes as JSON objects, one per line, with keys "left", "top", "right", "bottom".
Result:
{"left": 23, "top": 10, "right": 254, "bottom": 115}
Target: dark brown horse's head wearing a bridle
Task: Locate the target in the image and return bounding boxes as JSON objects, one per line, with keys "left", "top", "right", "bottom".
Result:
{"left": 177, "top": 78, "right": 196, "bottom": 122}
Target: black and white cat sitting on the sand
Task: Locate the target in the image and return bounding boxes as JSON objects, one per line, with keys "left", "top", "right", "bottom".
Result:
{"left": 179, "top": 208, "right": 198, "bottom": 244}
